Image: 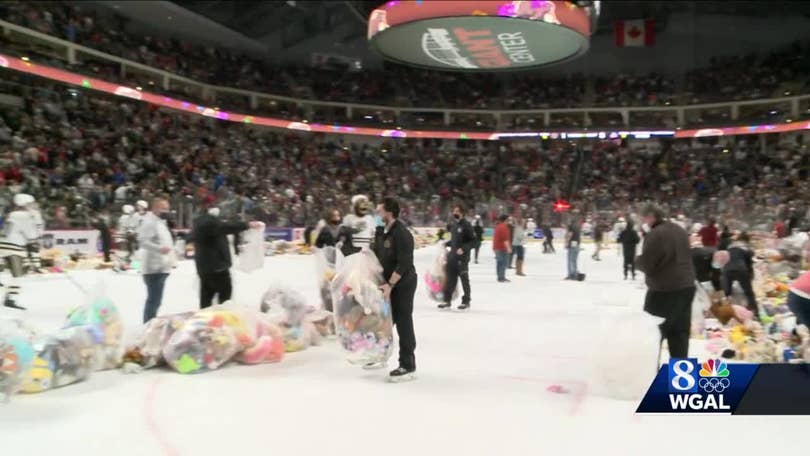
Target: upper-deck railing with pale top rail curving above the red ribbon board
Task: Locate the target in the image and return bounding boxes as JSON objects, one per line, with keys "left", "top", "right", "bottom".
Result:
{"left": 0, "top": 20, "right": 810, "bottom": 139}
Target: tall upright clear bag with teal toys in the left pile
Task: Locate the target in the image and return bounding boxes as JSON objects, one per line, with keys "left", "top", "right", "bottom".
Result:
{"left": 64, "top": 290, "right": 123, "bottom": 370}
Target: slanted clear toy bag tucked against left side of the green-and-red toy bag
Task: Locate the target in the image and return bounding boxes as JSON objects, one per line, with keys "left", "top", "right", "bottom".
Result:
{"left": 123, "top": 312, "right": 194, "bottom": 369}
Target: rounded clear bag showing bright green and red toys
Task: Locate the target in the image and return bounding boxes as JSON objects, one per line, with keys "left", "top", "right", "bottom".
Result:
{"left": 163, "top": 306, "right": 243, "bottom": 374}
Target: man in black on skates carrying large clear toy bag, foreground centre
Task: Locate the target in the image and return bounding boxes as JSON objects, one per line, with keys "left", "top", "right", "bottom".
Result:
{"left": 374, "top": 198, "right": 417, "bottom": 381}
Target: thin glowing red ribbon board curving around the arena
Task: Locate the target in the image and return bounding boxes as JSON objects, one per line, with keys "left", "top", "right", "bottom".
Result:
{"left": 0, "top": 54, "right": 810, "bottom": 141}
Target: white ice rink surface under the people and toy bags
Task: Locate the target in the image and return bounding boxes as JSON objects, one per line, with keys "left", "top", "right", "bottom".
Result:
{"left": 0, "top": 240, "right": 810, "bottom": 456}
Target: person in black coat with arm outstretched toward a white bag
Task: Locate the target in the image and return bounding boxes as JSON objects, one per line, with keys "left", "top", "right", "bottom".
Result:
{"left": 191, "top": 208, "right": 261, "bottom": 309}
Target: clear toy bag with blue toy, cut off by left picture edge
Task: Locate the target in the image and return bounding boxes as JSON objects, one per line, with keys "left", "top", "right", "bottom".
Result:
{"left": 0, "top": 320, "right": 35, "bottom": 402}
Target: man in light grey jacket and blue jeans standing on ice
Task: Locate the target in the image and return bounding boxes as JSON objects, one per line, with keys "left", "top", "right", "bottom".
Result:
{"left": 138, "top": 198, "right": 176, "bottom": 323}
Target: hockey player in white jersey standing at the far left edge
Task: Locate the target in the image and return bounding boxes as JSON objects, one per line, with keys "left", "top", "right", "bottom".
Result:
{"left": 0, "top": 193, "right": 38, "bottom": 310}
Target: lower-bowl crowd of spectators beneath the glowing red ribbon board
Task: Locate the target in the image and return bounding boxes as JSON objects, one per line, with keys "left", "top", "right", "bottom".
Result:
{"left": 0, "top": 70, "right": 810, "bottom": 233}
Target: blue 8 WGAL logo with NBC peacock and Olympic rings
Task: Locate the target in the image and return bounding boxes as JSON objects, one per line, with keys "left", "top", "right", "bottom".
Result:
{"left": 669, "top": 358, "right": 731, "bottom": 411}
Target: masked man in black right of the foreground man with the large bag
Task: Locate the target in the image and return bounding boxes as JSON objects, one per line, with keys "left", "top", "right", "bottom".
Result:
{"left": 439, "top": 204, "right": 475, "bottom": 310}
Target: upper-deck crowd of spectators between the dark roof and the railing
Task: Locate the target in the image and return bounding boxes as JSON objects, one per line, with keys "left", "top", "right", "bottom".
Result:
{"left": 0, "top": 1, "right": 810, "bottom": 116}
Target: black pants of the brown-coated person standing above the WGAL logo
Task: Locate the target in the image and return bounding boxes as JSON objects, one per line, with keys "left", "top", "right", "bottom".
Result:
{"left": 644, "top": 287, "right": 695, "bottom": 358}
